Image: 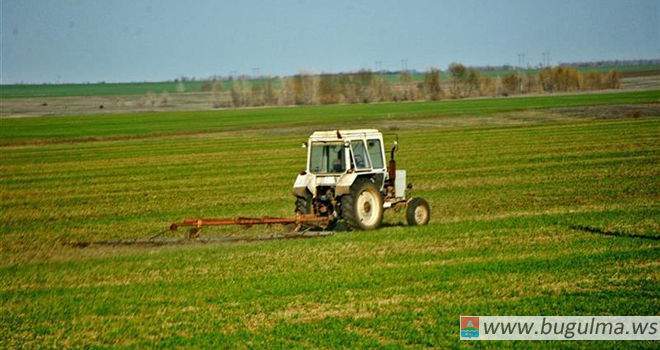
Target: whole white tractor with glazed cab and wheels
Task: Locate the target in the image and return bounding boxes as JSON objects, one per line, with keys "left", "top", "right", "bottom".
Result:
{"left": 293, "top": 129, "right": 431, "bottom": 230}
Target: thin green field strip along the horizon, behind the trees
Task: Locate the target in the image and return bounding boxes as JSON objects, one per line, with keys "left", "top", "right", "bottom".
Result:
{"left": 0, "top": 65, "right": 660, "bottom": 98}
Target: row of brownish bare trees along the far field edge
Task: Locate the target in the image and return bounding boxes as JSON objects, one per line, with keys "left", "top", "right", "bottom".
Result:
{"left": 197, "top": 63, "right": 622, "bottom": 108}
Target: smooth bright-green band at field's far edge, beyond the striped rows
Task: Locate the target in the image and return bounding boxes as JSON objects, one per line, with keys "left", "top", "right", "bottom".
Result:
{"left": 0, "top": 90, "right": 660, "bottom": 145}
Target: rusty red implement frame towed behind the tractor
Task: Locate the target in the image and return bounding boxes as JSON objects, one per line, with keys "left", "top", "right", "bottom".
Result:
{"left": 170, "top": 214, "right": 330, "bottom": 238}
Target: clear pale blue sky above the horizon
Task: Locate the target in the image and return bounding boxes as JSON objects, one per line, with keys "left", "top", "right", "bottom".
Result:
{"left": 0, "top": 0, "right": 660, "bottom": 84}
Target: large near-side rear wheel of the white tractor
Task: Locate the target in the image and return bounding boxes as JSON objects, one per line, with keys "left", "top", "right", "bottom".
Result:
{"left": 341, "top": 179, "right": 383, "bottom": 230}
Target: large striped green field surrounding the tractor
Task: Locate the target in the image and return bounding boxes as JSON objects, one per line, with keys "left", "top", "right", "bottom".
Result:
{"left": 0, "top": 91, "right": 660, "bottom": 349}
